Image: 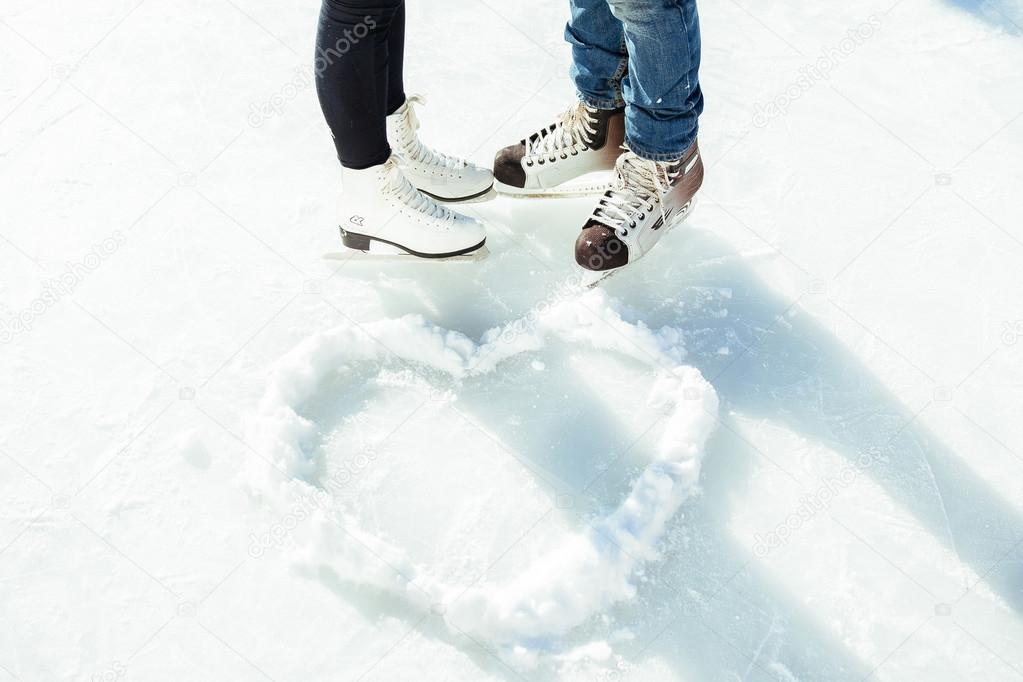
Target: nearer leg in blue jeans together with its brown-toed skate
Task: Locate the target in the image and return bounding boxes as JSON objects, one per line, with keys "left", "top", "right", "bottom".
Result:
{"left": 575, "top": 0, "right": 704, "bottom": 276}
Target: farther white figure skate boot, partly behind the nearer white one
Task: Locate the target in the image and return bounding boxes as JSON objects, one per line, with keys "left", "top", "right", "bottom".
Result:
{"left": 387, "top": 95, "right": 494, "bottom": 201}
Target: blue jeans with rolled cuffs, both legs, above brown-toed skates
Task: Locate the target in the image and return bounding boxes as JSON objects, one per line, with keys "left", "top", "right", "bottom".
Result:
{"left": 565, "top": 0, "right": 703, "bottom": 161}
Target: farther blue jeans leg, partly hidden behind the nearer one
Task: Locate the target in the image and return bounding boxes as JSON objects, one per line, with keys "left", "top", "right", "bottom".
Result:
{"left": 565, "top": 0, "right": 628, "bottom": 109}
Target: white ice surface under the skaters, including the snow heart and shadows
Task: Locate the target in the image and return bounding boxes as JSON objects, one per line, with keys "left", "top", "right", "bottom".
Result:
{"left": 0, "top": 0, "right": 1023, "bottom": 682}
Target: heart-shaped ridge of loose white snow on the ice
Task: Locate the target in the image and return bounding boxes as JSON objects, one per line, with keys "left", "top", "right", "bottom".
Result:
{"left": 248, "top": 291, "right": 718, "bottom": 663}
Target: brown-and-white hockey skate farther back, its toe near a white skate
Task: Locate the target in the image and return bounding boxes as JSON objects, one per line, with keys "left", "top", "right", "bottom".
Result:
{"left": 494, "top": 102, "right": 625, "bottom": 196}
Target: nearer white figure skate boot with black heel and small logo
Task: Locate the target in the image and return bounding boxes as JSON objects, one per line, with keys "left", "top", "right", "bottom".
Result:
{"left": 339, "top": 156, "right": 487, "bottom": 259}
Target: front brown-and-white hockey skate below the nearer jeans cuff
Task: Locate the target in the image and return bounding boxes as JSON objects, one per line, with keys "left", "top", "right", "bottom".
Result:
{"left": 575, "top": 142, "right": 704, "bottom": 283}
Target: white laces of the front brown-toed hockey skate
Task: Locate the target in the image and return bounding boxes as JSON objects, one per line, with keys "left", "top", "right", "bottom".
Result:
{"left": 592, "top": 152, "right": 678, "bottom": 236}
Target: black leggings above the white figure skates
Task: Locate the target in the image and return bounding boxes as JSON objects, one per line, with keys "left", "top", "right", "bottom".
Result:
{"left": 315, "top": 0, "right": 405, "bottom": 169}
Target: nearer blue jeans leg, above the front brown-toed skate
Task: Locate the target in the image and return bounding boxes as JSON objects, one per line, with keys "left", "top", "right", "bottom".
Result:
{"left": 608, "top": 0, "right": 704, "bottom": 162}
